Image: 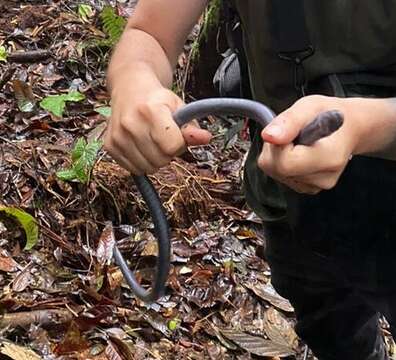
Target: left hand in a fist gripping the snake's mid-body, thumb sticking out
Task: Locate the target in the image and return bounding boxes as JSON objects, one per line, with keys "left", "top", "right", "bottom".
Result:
{"left": 104, "top": 82, "right": 212, "bottom": 175}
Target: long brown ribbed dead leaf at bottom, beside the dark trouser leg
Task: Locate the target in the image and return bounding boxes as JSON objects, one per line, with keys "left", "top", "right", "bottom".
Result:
{"left": 221, "top": 329, "right": 295, "bottom": 357}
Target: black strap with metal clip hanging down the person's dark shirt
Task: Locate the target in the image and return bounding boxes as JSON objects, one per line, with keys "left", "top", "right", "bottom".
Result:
{"left": 269, "top": 0, "right": 315, "bottom": 96}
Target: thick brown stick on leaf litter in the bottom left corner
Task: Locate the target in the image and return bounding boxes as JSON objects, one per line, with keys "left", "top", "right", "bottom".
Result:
{"left": 0, "top": 309, "right": 73, "bottom": 328}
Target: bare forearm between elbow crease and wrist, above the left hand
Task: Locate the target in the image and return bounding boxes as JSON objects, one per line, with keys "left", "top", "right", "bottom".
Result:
{"left": 107, "top": 27, "right": 173, "bottom": 93}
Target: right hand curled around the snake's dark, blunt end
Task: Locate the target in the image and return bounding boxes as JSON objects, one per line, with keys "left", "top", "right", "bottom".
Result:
{"left": 258, "top": 95, "right": 362, "bottom": 194}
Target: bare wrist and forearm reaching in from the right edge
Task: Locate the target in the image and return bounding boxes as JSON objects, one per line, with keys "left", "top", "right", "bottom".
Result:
{"left": 348, "top": 98, "right": 396, "bottom": 160}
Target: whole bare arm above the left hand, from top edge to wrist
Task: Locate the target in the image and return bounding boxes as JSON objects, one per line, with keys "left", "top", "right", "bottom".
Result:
{"left": 108, "top": 0, "right": 207, "bottom": 92}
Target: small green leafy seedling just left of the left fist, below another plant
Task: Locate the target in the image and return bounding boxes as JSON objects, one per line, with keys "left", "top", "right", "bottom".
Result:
{"left": 56, "top": 138, "right": 103, "bottom": 184}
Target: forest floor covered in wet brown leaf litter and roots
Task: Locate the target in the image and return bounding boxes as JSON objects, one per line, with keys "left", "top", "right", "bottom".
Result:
{"left": 0, "top": 0, "right": 392, "bottom": 360}
